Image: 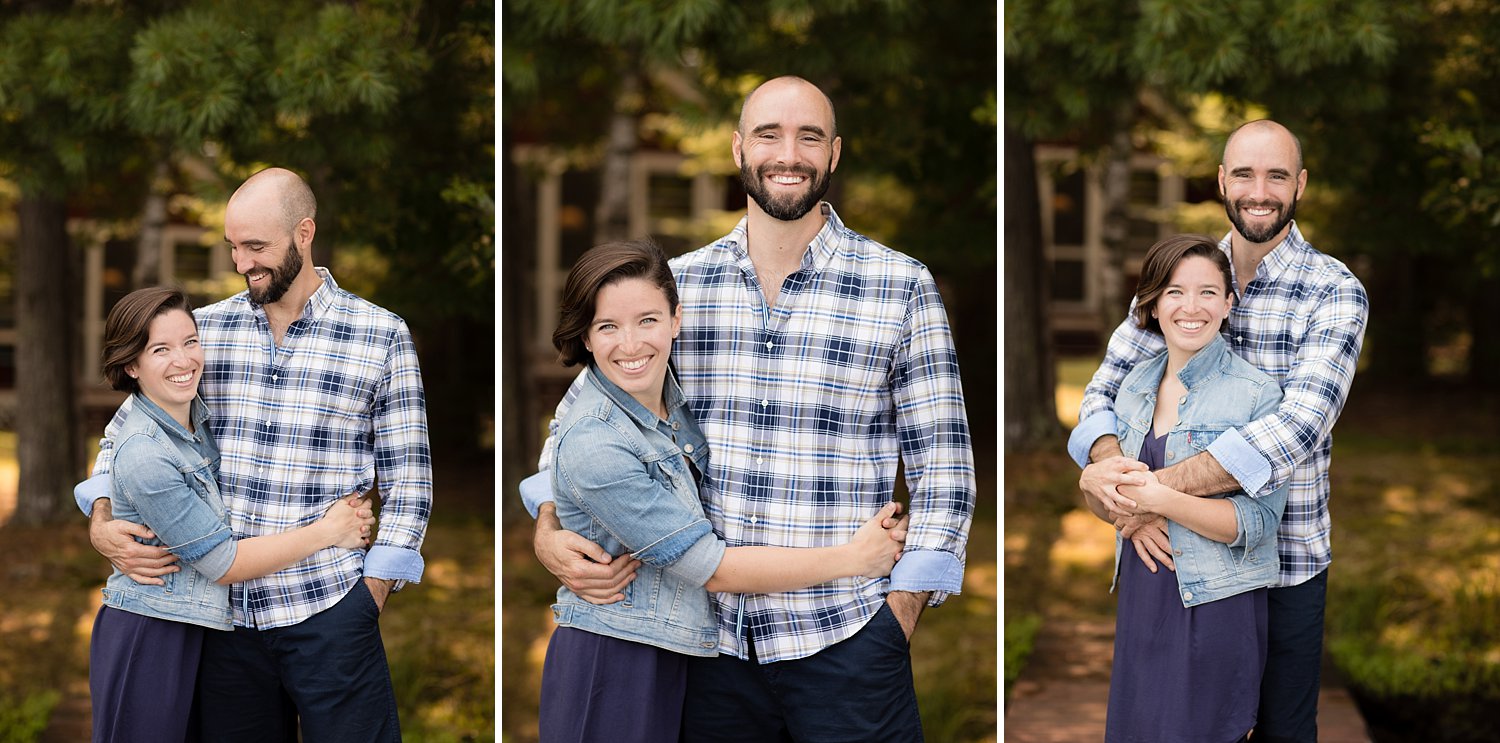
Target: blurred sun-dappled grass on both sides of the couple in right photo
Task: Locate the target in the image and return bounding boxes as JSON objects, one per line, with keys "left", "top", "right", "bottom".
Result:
{"left": 1005, "top": 367, "right": 1500, "bottom": 743}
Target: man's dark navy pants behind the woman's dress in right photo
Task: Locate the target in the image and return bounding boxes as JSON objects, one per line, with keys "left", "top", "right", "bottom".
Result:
{"left": 1254, "top": 570, "right": 1328, "bottom": 743}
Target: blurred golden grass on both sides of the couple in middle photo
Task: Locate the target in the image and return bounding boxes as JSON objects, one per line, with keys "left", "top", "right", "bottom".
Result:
{"left": 501, "top": 462, "right": 998, "bottom": 743}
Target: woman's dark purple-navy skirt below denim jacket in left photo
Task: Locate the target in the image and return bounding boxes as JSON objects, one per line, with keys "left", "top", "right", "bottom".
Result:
{"left": 89, "top": 606, "right": 212, "bottom": 743}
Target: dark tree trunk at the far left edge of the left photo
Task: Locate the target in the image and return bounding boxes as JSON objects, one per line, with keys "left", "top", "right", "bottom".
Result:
{"left": 15, "top": 195, "right": 83, "bottom": 525}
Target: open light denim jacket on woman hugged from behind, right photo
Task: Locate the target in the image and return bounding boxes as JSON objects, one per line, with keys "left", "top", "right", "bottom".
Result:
{"left": 1112, "top": 336, "right": 1287, "bottom": 606}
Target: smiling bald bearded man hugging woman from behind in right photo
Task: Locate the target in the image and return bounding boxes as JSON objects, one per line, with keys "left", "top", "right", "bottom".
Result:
{"left": 1068, "top": 120, "right": 1370, "bottom": 743}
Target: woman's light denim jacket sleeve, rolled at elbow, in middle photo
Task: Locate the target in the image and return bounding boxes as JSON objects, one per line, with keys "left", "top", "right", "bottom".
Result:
{"left": 554, "top": 417, "right": 722, "bottom": 581}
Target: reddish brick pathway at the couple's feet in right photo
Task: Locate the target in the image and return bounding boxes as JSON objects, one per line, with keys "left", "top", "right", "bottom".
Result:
{"left": 1005, "top": 618, "right": 1370, "bottom": 743}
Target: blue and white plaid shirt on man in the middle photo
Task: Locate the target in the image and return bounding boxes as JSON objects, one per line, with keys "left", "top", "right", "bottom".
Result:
{"left": 528, "top": 204, "right": 975, "bottom": 663}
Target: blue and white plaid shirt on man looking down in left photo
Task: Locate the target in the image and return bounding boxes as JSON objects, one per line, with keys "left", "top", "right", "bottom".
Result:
{"left": 78, "top": 269, "right": 432, "bottom": 629}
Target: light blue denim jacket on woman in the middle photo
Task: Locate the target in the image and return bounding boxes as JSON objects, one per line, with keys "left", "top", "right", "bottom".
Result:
{"left": 552, "top": 366, "right": 725, "bottom": 656}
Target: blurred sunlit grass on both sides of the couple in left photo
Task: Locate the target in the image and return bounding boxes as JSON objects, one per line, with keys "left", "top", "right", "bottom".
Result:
{"left": 0, "top": 459, "right": 495, "bottom": 743}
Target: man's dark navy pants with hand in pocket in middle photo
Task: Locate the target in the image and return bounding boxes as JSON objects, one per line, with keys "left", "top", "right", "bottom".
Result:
{"left": 683, "top": 605, "right": 923, "bottom": 743}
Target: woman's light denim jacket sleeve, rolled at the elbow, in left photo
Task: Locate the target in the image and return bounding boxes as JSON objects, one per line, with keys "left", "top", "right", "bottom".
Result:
{"left": 111, "top": 434, "right": 233, "bottom": 575}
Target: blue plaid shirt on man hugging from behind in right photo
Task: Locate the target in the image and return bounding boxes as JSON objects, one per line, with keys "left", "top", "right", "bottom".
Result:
{"left": 1068, "top": 222, "right": 1370, "bottom": 585}
